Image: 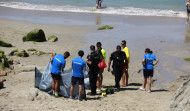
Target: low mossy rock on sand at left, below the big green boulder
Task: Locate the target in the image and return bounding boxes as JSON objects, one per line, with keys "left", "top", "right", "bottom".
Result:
{"left": 9, "top": 49, "right": 29, "bottom": 57}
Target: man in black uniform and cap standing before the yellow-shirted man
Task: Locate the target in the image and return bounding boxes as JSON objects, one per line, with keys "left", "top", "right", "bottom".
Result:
{"left": 108, "top": 45, "right": 127, "bottom": 91}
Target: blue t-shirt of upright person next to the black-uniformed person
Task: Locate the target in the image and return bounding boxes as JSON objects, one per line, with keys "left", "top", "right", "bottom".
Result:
{"left": 72, "top": 57, "right": 86, "bottom": 77}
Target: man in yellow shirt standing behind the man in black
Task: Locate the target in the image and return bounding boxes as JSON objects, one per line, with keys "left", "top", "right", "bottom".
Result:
{"left": 121, "top": 40, "right": 130, "bottom": 86}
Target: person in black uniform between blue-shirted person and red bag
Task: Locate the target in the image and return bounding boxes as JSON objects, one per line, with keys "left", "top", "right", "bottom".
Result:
{"left": 86, "top": 45, "right": 101, "bottom": 96}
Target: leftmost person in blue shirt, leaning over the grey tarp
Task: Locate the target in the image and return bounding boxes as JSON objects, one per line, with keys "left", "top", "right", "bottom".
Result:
{"left": 51, "top": 51, "right": 70, "bottom": 97}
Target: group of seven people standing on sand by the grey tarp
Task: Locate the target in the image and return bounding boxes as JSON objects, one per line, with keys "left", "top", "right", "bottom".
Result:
{"left": 51, "top": 40, "right": 158, "bottom": 100}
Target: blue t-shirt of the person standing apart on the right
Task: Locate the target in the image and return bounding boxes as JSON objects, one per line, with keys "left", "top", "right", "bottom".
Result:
{"left": 143, "top": 53, "right": 157, "bottom": 69}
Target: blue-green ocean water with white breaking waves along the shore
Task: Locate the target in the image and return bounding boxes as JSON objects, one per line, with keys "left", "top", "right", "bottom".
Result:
{"left": 0, "top": 0, "right": 186, "bottom": 17}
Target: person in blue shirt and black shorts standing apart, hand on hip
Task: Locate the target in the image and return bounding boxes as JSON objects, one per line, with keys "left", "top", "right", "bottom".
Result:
{"left": 140, "top": 48, "right": 158, "bottom": 93}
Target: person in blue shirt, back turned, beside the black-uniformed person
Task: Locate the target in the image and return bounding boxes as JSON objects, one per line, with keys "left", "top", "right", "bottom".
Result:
{"left": 70, "top": 50, "right": 86, "bottom": 101}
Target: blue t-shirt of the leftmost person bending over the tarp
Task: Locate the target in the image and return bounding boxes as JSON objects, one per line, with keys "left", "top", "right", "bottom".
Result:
{"left": 51, "top": 54, "right": 66, "bottom": 74}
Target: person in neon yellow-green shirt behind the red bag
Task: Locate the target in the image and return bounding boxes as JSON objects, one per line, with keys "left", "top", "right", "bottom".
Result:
{"left": 96, "top": 42, "right": 106, "bottom": 93}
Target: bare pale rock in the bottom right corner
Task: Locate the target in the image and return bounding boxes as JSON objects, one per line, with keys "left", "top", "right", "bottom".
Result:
{"left": 169, "top": 79, "right": 190, "bottom": 111}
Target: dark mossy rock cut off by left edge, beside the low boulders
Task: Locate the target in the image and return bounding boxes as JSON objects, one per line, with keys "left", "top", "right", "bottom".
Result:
{"left": 0, "top": 52, "right": 9, "bottom": 69}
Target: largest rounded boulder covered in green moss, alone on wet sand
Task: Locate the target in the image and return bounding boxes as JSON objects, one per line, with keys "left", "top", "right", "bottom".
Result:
{"left": 22, "top": 29, "right": 46, "bottom": 42}
